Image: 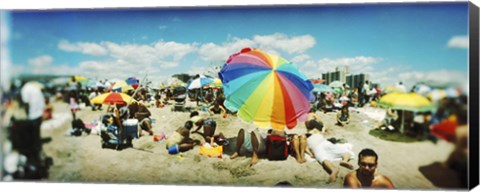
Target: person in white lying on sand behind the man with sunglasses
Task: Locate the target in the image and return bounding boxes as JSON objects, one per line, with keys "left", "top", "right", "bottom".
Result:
{"left": 307, "top": 133, "right": 353, "bottom": 183}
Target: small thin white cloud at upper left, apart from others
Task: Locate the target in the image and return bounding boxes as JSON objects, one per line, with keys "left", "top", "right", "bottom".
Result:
{"left": 58, "top": 40, "right": 107, "bottom": 56}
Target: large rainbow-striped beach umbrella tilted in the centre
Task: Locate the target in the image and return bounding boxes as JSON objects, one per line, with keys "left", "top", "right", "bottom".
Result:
{"left": 219, "top": 48, "right": 314, "bottom": 130}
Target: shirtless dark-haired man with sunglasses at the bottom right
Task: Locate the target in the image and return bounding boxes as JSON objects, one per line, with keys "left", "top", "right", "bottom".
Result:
{"left": 343, "top": 149, "right": 395, "bottom": 189}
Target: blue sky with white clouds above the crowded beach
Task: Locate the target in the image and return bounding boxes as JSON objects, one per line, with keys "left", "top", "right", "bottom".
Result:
{"left": 1, "top": 2, "right": 468, "bottom": 89}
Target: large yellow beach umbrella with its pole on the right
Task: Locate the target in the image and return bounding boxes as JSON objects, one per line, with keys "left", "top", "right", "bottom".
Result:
{"left": 378, "top": 92, "right": 434, "bottom": 133}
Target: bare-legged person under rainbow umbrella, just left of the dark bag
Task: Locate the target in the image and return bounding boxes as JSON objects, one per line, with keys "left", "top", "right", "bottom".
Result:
{"left": 230, "top": 128, "right": 267, "bottom": 166}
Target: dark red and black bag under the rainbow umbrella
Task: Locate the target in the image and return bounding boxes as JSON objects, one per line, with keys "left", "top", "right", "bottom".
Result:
{"left": 266, "top": 135, "right": 288, "bottom": 161}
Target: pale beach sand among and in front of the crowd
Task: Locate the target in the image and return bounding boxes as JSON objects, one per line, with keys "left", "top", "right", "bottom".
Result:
{"left": 42, "top": 102, "right": 456, "bottom": 189}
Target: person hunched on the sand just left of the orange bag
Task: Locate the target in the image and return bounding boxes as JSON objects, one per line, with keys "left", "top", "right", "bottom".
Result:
{"left": 166, "top": 121, "right": 200, "bottom": 153}
